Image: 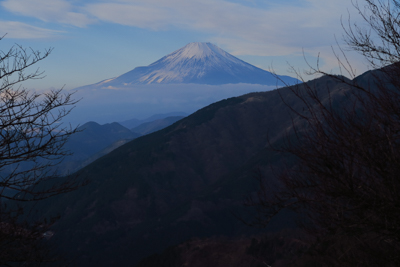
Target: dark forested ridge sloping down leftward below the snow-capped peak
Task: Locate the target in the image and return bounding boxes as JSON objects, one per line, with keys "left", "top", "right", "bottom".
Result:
{"left": 32, "top": 72, "right": 365, "bottom": 266}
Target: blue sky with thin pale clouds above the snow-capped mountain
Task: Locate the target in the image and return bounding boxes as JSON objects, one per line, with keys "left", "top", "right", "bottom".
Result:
{"left": 0, "top": 0, "right": 367, "bottom": 89}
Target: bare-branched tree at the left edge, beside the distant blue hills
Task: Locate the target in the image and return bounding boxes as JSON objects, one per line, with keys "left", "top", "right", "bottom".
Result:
{"left": 0, "top": 38, "right": 79, "bottom": 266}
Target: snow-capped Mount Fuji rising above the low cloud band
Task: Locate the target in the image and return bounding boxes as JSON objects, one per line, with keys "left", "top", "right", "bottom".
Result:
{"left": 85, "top": 43, "right": 299, "bottom": 89}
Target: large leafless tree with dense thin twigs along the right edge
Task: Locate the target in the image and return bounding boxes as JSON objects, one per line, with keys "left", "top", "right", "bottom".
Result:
{"left": 247, "top": 0, "right": 400, "bottom": 266}
